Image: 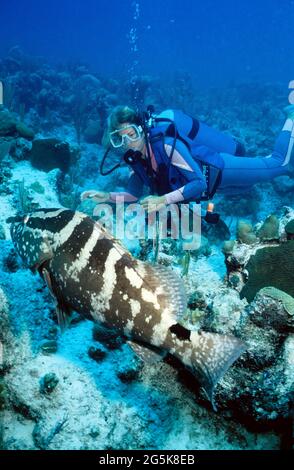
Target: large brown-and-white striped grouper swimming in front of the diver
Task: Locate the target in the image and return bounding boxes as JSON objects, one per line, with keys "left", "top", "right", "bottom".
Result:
{"left": 11, "top": 209, "right": 246, "bottom": 401}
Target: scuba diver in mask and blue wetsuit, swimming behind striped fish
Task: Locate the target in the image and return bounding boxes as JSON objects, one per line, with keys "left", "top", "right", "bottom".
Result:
{"left": 81, "top": 105, "right": 294, "bottom": 219}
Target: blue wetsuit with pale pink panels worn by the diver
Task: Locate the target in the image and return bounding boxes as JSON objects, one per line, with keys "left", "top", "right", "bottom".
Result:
{"left": 112, "top": 110, "right": 294, "bottom": 204}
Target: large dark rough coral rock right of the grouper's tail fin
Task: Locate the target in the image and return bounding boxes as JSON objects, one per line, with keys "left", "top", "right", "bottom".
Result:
{"left": 211, "top": 290, "right": 294, "bottom": 430}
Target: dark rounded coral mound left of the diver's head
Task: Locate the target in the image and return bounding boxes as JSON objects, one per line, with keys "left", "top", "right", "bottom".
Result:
{"left": 30, "top": 139, "right": 72, "bottom": 172}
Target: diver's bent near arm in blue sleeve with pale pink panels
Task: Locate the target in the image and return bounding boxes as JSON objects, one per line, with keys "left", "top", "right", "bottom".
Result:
{"left": 165, "top": 141, "right": 207, "bottom": 204}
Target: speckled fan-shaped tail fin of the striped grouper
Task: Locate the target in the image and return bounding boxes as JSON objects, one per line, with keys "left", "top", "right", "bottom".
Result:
{"left": 190, "top": 331, "right": 247, "bottom": 409}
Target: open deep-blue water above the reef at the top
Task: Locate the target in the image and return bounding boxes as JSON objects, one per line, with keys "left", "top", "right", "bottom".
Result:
{"left": 0, "top": 0, "right": 294, "bottom": 87}
